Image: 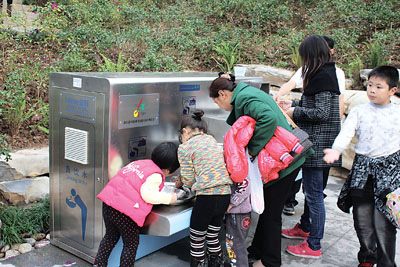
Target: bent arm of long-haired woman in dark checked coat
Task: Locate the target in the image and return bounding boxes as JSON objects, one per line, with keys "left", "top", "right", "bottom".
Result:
{"left": 287, "top": 91, "right": 332, "bottom": 121}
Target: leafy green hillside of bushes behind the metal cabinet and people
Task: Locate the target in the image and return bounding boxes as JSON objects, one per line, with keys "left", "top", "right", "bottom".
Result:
{"left": 0, "top": 0, "right": 400, "bottom": 146}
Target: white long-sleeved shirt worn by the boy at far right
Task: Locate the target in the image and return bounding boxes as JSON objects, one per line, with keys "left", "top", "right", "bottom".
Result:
{"left": 332, "top": 102, "right": 400, "bottom": 158}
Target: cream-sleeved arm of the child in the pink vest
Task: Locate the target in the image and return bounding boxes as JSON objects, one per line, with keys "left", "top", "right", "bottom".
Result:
{"left": 140, "top": 173, "right": 177, "bottom": 204}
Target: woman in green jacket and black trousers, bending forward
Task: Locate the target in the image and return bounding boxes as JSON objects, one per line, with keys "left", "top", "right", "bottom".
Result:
{"left": 209, "top": 73, "right": 305, "bottom": 267}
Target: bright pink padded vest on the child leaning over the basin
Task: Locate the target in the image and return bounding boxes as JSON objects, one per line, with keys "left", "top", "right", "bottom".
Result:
{"left": 97, "top": 159, "right": 165, "bottom": 227}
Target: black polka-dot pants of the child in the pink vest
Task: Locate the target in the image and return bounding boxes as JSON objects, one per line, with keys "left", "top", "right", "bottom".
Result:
{"left": 93, "top": 203, "right": 140, "bottom": 267}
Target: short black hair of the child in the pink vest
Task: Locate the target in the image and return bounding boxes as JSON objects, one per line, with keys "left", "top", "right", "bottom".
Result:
{"left": 151, "top": 142, "right": 180, "bottom": 173}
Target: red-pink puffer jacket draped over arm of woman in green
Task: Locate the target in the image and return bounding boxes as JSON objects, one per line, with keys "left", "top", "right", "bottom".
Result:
{"left": 224, "top": 116, "right": 303, "bottom": 183}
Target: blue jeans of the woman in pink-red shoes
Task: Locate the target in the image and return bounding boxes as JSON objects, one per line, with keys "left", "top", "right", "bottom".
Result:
{"left": 300, "top": 167, "right": 329, "bottom": 250}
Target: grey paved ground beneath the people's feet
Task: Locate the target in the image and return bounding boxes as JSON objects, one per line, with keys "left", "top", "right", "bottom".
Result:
{"left": 0, "top": 177, "right": 400, "bottom": 267}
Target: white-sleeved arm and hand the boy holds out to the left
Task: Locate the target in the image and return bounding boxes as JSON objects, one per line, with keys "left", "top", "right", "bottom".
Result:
{"left": 323, "top": 108, "right": 358, "bottom": 164}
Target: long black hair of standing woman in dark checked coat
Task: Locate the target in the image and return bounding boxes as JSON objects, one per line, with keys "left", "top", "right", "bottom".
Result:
{"left": 299, "top": 34, "right": 331, "bottom": 88}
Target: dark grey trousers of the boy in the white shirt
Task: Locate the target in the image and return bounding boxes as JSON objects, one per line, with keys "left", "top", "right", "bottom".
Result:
{"left": 352, "top": 194, "right": 396, "bottom": 267}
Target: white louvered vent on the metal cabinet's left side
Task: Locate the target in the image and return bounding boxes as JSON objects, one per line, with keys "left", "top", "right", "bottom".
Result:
{"left": 64, "top": 127, "right": 89, "bottom": 164}
